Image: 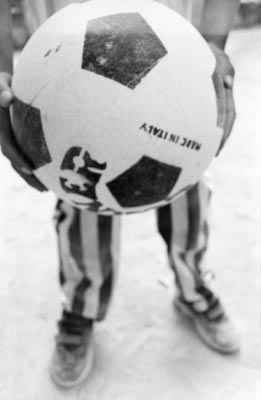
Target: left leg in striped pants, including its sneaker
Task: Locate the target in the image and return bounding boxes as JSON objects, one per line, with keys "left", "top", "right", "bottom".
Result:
{"left": 51, "top": 201, "right": 120, "bottom": 387}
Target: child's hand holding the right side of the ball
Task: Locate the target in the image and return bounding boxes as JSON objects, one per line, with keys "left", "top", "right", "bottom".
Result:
{"left": 209, "top": 43, "right": 236, "bottom": 153}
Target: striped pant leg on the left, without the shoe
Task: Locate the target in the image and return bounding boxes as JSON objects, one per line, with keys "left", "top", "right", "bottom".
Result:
{"left": 55, "top": 200, "right": 120, "bottom": 320}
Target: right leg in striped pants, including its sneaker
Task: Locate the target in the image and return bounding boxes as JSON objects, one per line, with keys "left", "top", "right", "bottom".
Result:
{"left": 157, "top": 182, "right": 239, "bottom": 353}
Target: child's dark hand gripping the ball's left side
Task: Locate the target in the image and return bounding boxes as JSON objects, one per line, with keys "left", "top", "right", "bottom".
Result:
{"left": 0, "top": 72, "right": 46, "bottom": 192}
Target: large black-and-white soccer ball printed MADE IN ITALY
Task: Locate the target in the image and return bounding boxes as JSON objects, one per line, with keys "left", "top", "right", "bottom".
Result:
{"left": 11, "top": 0, "right": 222, "bottom": 214}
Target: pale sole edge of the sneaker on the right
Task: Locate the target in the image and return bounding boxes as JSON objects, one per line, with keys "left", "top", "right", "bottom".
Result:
{"left": 173, "top": 299, "right": 239, "bottom": 355}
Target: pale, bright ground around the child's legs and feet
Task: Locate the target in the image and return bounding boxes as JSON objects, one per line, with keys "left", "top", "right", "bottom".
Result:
{"left": 0, "top": 28, "right": 261, "bottom": 400}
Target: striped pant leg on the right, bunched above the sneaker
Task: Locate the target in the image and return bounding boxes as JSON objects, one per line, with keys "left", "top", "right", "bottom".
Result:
{"left": 157, "top": 181, "right": 211, "bottom": 310}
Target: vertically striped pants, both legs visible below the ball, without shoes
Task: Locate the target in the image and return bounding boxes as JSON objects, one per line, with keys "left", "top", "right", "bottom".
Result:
{"left": 55, "top": 181, "right": 210, "bottom": 320}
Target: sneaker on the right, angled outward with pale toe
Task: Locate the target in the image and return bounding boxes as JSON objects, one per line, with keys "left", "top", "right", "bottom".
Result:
{"left": 174, "top": 291, "right": 240, "bottom": 354}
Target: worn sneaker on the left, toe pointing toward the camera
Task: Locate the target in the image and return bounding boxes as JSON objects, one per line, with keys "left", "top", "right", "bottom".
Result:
{"left": 51, "top": 311, "right": 93, "bottom": 388}
